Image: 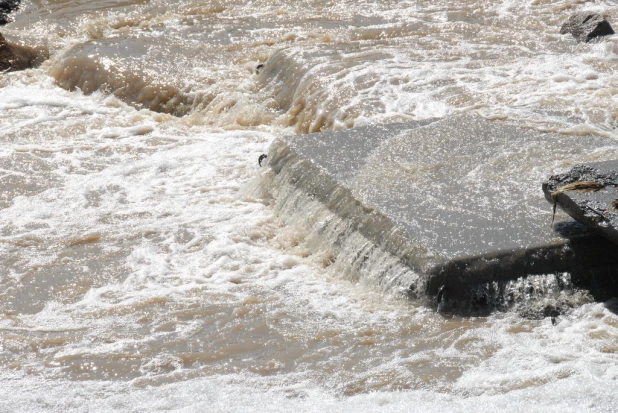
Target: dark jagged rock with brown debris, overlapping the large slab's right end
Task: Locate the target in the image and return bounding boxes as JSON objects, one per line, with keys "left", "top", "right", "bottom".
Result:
{"left": 543, "top": 160, "right": 618, "bottom": 244}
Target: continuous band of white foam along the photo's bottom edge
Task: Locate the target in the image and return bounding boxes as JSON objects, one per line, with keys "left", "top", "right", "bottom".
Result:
{"left": 0, "top": 360, "right": 615, "bottom": 412}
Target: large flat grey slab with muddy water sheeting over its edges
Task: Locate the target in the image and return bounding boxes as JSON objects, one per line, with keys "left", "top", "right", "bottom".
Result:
{"left": 266, "top": 116, "right": 618, "bottom": 311}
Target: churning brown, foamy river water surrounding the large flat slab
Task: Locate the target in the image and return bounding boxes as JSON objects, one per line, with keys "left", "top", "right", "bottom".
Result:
{"left": 0, "top": 0, "right": 618, "bottom": 412}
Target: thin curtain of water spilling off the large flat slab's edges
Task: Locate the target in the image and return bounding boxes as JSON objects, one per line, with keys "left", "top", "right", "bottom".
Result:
{"left": 250, "top": 141, "right": 593, "bottom": 318}
